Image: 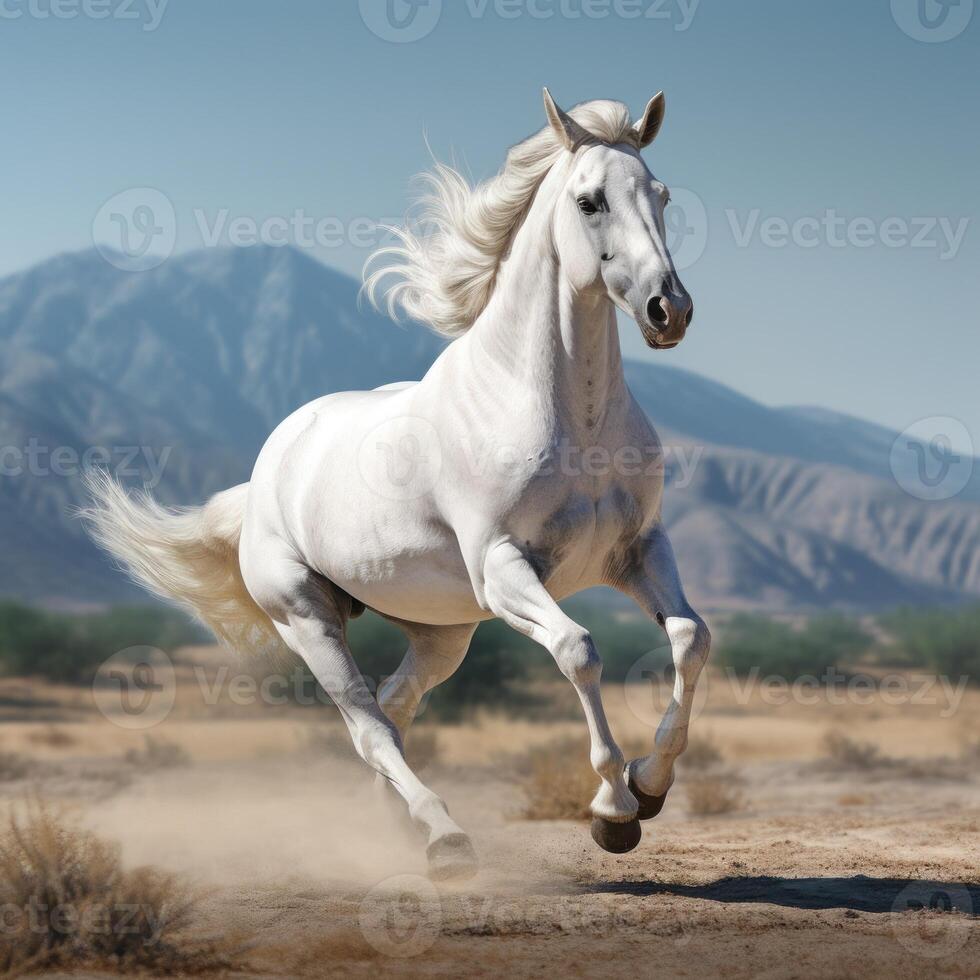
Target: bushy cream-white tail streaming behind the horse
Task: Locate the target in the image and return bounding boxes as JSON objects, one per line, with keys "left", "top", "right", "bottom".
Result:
{"left": 81, "top": 470, "right": 281, "bottom": 652}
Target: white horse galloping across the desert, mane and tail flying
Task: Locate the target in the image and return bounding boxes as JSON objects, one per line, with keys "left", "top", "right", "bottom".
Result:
{"left": 88, "top": 89, "right": 709, "bottom": 877}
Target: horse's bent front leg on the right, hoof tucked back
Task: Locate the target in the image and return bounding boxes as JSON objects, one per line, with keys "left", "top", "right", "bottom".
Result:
{"left": 611, "top": 525, "right": 711, "bottom": 820}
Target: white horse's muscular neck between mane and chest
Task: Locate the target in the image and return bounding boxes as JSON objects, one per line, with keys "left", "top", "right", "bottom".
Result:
{"left": 471, "top": 183, "right": 625, "bottom": 437}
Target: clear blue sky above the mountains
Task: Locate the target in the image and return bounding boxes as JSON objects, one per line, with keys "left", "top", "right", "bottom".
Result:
{"left": 0, "top": 0, "right": 980, "bottom": 450}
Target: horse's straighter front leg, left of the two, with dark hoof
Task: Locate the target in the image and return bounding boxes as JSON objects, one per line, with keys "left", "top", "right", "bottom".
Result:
{"left": 484, "top": 542, "right": 640, "bottom": 854}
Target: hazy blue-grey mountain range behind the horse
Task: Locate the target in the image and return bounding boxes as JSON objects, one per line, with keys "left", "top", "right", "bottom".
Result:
{"left": 0, "top": 247, "right": 980, "bottom": 610}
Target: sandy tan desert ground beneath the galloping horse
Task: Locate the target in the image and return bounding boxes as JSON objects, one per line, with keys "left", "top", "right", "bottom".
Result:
{"left": 0, "top": 648, "right": 980, "bottom": 980}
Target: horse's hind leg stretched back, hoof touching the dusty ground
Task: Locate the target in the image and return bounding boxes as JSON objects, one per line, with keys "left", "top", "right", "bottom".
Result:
{"left": 262, "top": 566, "right": 476, "bottom": 878}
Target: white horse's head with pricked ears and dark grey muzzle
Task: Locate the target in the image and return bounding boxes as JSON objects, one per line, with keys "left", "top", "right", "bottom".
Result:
{"left": 544, "top": 89, "right": 694, "bottom": 349}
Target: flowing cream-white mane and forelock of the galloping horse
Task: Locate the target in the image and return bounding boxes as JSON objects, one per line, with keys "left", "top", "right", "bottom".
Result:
{"left": 364, "top": 99, "right": 639, "bottom": 337}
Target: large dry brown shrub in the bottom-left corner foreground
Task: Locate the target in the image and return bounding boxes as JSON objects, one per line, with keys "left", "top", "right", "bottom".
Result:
{"left": 0, "top": 801, "right": 232, "bottom": 976}
